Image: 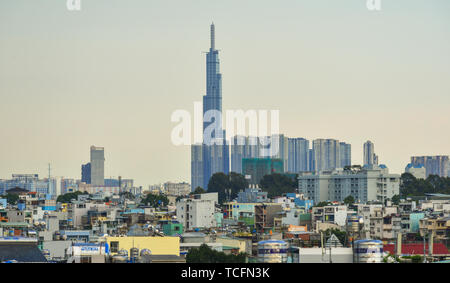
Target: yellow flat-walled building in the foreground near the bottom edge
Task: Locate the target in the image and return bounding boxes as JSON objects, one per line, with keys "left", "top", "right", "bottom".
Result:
{"left": 106, "top": 236, "right": 180, "bottom": 256}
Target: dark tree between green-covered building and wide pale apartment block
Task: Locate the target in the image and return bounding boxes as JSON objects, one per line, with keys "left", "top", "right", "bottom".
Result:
{"left": 260, "top": 173, "right": 298, "bottom": 198}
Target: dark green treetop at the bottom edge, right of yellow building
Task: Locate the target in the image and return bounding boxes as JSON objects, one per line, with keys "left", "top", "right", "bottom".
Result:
{"left": 186, "top": 244, "right": 247, "bottom": 263}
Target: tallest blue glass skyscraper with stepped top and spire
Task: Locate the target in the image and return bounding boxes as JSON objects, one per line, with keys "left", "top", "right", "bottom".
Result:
{"left": 191, "top": 24, "right": 230, "bottom": 189}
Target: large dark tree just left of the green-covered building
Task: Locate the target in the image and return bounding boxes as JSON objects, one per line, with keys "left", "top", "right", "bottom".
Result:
{"left": 208, "top": 172, "right": 248, "bottom": 204}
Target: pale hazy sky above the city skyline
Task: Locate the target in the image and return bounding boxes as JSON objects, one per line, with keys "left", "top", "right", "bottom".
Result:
{"left": 0, "top": 0, "right": 450, "bottom": 189}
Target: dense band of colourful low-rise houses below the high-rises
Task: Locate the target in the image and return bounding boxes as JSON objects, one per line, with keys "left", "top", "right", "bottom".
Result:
{"left": 0, "top": 182, "right": 450, "bottom": 262}
